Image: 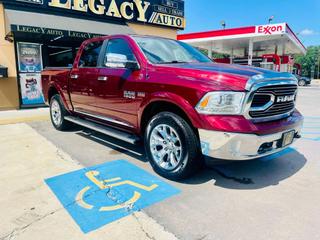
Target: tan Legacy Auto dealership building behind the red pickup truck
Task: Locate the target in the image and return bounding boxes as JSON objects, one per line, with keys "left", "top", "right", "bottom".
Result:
{"left": 0, "top": 0, "right": 185, "bottom": 110}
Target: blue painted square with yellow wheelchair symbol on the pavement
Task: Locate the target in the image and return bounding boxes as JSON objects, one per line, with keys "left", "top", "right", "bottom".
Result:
{"left": 45, "top": 160, "right": 180, "bottom": 233}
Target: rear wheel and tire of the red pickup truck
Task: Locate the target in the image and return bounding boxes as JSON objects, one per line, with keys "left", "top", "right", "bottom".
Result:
{"left": 50, "top": 94, "right": 72, "bottom": 131}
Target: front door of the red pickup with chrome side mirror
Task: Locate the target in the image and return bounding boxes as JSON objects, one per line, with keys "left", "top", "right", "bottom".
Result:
{"left": 96, "top": 38, "right": 143, "bottom": 128}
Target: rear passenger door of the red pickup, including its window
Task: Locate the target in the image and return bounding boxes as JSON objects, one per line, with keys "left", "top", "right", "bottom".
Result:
{"left": 69, "top": 41, "right": 103, "bottom": 114}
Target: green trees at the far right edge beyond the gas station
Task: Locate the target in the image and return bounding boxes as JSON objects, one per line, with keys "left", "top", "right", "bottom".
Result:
{"left": 295, "top": 46, "right": 320, "bottom": 77}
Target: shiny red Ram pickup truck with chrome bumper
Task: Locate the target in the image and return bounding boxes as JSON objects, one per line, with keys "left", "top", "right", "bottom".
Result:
{"left": 42, "top": 35, "right": 303, "bottom": 179}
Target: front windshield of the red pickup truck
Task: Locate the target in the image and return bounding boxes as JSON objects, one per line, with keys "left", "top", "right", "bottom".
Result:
{"left": 133, "top": 36, "right": 212, "bottom": 64}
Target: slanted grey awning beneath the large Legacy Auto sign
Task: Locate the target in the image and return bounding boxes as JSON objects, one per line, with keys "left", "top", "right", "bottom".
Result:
{"left": 5, "top": 9, "right": 134, "bottom": 35}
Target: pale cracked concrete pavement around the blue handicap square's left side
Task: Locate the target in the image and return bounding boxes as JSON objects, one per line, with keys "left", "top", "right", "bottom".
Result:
{"left": 0, "top": 124, "right": 176, "bottom": 240}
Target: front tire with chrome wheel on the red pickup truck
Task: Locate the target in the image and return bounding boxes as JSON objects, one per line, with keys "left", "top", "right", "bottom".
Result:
{"left": 144, "top": 112, "right": 203, "bottom": 180}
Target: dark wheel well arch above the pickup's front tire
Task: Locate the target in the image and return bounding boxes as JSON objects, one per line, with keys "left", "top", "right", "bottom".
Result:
{"left": 140, "top": 101, "right": 198, "bottom": 135}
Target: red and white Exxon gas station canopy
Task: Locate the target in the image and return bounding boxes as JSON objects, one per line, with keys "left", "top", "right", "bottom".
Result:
{"left": 178, "top": 23, "right": 306, "bottom": 58}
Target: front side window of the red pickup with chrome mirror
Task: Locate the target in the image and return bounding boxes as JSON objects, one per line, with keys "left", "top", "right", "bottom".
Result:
{"left": 104, "top": 39, "right": 136, "bottom": 68}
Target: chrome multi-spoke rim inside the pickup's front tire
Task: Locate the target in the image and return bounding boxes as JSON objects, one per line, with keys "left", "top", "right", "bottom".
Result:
{"left": 150, "top": 124, "right": 182, "bottom": 171}
